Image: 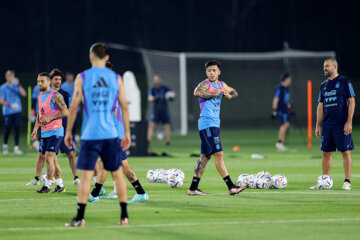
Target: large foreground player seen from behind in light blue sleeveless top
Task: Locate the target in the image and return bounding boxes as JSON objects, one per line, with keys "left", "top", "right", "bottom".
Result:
{"left": 65, "top": 43, "right": 131, "bottom": 227}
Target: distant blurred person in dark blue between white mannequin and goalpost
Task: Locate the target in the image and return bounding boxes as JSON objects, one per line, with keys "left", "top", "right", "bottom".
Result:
{"left": 147, "top": 75, "right": 175, "bottom": 146}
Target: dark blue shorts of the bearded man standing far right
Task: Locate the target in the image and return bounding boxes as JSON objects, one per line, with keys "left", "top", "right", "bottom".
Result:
{"left": 321, "top": 125, "right": 354, "bottom": 152}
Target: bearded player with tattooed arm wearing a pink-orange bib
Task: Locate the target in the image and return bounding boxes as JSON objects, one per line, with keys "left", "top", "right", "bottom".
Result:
{"left": 31, "top": 73, "right": 69, "bottom": 193}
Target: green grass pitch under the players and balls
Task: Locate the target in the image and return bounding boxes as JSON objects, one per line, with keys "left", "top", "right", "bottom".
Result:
{"left": 0, "top": 130, "right": 360, "bottom": 240}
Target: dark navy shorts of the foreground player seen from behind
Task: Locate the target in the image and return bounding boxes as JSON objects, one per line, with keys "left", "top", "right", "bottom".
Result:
{"left": 76, "top": 138, "right": 122, "bottom": 171}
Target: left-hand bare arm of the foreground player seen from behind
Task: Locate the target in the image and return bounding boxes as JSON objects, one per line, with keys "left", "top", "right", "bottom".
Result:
{"left": 64, "top": 74, "right": 83, "bottom": 148}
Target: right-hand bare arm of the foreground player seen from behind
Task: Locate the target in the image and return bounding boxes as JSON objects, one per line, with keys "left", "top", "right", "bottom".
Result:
{"left": 118, "top": 77, "right": 131, "bottom": 151}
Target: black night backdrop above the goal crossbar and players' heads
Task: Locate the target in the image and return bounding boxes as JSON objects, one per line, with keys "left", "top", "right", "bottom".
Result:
{"left": 0, "top": 0, "right": 360, "bottom": 127}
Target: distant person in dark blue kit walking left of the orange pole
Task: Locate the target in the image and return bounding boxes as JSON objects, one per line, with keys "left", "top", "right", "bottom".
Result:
{"left": 272, "top": 73, "right": 292, "bottom": 151}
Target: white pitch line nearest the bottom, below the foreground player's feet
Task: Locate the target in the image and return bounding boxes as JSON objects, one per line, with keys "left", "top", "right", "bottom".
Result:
{"left": 0, "top": 218, "right": 360, "bottom": 232}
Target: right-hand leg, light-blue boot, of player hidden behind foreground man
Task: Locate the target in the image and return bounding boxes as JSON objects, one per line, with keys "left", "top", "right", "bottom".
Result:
{"left": 122, "top": 159, "right": 149, "bottom": 203}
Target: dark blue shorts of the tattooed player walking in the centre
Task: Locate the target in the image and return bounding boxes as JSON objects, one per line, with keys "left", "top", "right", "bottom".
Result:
{"left": 199, "top": 127, "right": 223, "bottom": 156}
